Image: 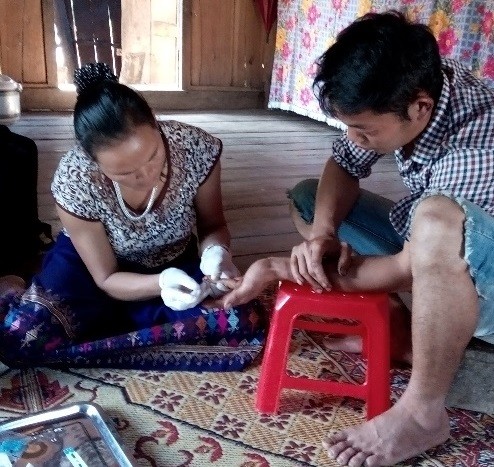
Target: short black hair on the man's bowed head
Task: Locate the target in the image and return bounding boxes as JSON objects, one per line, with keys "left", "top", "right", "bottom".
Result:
{"left": 314, "top": 11, "right": 443, "bottom": 120}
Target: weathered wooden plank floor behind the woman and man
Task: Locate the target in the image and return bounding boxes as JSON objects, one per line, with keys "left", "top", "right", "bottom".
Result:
{"left": 10, "top": 110, "right": 406, "bottom": 269}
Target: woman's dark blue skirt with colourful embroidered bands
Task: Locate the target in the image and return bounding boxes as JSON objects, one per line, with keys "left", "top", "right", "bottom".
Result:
{"left": 0, "top": 234, "right": 268, "bottom": 371}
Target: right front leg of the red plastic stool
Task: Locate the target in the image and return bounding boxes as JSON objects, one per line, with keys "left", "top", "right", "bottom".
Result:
{"left": 366, "top": 304, "right": 390, "bottom": 420}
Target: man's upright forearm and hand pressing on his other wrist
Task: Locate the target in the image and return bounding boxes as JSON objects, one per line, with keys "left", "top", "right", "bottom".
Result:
{"left": 290, "top": 158, "right": 360, "bottom": 290}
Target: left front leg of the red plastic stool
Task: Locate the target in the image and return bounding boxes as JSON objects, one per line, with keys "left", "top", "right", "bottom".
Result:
{"left": 256, "top": 303, "right": 295, "bottom": 413}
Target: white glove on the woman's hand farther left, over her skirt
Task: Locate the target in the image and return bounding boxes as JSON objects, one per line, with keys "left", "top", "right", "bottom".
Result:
{"left": 159, "top": 268, "right": 209, "bottom": 311}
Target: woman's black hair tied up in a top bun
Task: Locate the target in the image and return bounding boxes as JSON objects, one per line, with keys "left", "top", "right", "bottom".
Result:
{"left": 74, "top": 63, "right": 156, "bottom": 158}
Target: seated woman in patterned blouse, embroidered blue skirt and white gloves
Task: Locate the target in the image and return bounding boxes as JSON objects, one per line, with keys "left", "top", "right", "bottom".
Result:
{"left": 2, "top": 64, "right": 264, "bottom": 371}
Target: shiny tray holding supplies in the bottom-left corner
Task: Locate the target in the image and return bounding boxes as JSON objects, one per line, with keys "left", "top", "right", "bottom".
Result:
{"left": 0, "top": 402, "right": 135, "bottom": 467}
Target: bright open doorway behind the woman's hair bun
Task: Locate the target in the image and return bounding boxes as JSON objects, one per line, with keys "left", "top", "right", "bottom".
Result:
{"left": 54, "top": 0, "right": 183, "bottom": 90}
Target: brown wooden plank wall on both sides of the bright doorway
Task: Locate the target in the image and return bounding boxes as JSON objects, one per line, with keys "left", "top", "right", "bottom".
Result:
{"left": 0, "top": 0, "right": 276, "bottom": 110}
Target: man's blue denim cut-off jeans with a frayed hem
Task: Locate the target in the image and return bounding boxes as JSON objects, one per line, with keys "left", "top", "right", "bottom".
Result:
{"left": 288, "top": 179, "right": 494, "bottom": 344}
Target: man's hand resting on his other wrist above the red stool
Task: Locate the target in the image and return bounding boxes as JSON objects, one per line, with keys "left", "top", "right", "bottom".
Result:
{"left": 290, "top": 236, "right": 352, "bottom": 292}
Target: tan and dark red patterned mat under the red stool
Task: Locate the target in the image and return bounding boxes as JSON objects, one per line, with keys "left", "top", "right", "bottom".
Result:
{"left": 0, "top": 294, "right": 494, "bottom": 467}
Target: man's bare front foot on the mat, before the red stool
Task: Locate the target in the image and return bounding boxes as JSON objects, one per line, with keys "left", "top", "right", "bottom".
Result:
{"left": 323, "top": 398, "right": 450, "bottom": 467}
